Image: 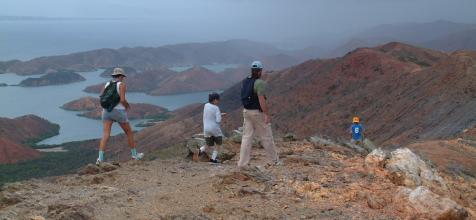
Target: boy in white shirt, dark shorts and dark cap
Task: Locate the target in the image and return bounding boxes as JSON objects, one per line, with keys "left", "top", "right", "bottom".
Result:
{"left": 199, "top": 93, "right": 226, "bottom": 163}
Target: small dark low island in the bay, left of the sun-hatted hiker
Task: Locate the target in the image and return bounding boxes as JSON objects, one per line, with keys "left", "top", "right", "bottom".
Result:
{"left": 19, "top": 71, "right": 86, "bottom": 87}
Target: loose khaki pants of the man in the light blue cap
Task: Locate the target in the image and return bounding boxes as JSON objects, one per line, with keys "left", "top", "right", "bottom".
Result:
{"left": 238, "top": 109, "right": 278, "bottom": 167}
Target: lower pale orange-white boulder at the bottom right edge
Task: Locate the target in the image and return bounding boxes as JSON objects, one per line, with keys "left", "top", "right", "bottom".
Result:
{"left": 394, "top": 186, "right": 468, "bottom": 220}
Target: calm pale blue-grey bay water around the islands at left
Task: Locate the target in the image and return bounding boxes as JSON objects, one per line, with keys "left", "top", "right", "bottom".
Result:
{"left": 0, "top": 70, "right": 208, "bottom": 144}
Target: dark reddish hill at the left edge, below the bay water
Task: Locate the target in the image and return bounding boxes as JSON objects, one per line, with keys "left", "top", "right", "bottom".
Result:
{"left": 0, "top": 115, "right": 59, "bottom": 164}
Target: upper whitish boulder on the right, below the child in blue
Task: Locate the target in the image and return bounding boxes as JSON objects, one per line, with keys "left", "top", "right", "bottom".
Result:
{"left": 385, "top": 148, "right": 447, "bottom": 189}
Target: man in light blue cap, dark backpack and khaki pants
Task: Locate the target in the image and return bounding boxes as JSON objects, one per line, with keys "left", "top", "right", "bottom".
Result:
{"left": 238, "top": 61, "right": 281, "bottom": 168}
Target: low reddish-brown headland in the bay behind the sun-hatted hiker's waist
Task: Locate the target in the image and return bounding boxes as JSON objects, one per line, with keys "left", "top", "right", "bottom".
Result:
{"left": 61, "top": 97, "right": 169, "bottom": 120}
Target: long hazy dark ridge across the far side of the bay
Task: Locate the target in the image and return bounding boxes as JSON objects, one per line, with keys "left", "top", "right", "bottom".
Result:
{"left": 0, "top": 40, "right": 302, "bottom": 75}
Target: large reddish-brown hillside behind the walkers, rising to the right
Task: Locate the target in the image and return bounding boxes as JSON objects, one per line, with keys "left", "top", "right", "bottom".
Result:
{"left": 112, "top": 43, "right": 476, "bottom": 168}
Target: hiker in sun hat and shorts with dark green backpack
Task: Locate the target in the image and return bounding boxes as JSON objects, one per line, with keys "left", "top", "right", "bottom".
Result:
{"left": 96, "top": 68, "right": 144, "bottom": 165}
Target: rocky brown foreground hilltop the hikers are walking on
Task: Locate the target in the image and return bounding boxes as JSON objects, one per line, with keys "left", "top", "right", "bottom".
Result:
{"left": 0, "top": 139, "right": 476, "bottom": 220}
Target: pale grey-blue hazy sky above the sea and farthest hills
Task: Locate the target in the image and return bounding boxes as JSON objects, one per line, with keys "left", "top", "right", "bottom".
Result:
{"left": 0, "top": 0, "right": 476, "bottom": 35}
